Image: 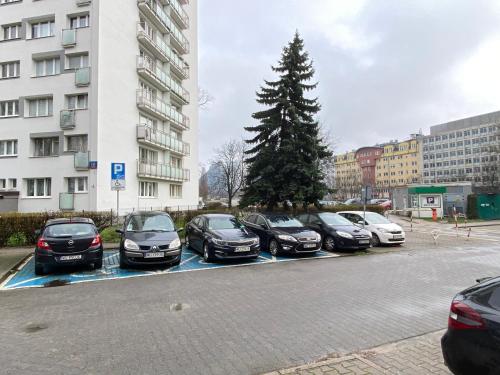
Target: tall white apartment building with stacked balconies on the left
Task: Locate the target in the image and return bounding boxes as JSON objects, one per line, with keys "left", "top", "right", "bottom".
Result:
{"left": 0, "top": 0, "right": 198, "bottom": 212}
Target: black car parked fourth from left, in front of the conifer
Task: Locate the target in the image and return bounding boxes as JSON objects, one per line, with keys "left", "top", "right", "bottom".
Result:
{"left": 243, "top": 213, "right": 321, "bottom": 256}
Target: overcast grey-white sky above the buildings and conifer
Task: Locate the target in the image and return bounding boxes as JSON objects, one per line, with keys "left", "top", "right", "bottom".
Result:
{"left": 199, "top": 0, "right": 500, "bottom": 163}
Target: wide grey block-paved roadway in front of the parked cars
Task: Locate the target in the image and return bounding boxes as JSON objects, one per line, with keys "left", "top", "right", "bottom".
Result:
{"left": 0, "top": 233, "right": 500, "bottom": 375}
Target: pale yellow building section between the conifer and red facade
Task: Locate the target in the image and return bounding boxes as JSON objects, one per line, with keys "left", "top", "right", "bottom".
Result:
{"left": 334, "top": 151, "right": 362, "bottom": 198}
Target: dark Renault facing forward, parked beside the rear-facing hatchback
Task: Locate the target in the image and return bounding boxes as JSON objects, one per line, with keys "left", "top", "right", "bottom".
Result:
{"left": 117, "top": 211, "right": 182, "bottom": 268}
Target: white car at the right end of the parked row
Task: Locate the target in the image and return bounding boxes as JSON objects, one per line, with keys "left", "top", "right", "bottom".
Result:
{"left": 338, "top": 211, "right": 406, "bottom": 246}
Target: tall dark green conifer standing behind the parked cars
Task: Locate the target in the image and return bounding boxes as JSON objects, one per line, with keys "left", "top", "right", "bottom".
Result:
{"left": 242, "top": 33, "right": 331, "bottom": 209}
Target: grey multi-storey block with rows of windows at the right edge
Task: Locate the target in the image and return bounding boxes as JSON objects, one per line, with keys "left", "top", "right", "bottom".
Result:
{"left": 422, "top": 111, "right": 500, "bottom": 187}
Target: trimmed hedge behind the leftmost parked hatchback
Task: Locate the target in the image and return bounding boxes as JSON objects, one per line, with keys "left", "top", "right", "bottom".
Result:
{"left": 0, "top": 211, "right": 112, "bottom": 247}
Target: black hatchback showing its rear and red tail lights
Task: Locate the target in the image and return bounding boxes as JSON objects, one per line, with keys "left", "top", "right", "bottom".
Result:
{"left": 35, "top": 218, "right": 103, "bottom": 275}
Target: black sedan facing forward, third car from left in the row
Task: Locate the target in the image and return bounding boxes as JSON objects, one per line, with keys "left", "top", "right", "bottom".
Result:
{"left": 186, "top": 214, "right": 260, "bottom": 262}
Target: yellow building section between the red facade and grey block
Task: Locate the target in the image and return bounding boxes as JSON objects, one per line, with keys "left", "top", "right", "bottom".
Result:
{"left": 375, "top": 136, "right": 422, "bottom": 197}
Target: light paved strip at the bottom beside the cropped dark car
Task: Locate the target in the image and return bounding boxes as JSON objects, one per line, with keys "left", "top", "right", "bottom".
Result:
{"left": 266, "top": 331, "right": 451, "bottom": 375}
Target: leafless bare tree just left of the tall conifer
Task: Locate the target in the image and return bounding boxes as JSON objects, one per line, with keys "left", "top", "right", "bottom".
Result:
{"left": 212, "top": 139, "right": 245, "bottom": 208}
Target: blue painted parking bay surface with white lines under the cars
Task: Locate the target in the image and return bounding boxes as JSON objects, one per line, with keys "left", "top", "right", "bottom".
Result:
{"left": 0, "top": 249, "right": 339, "bottom": 289}
